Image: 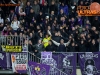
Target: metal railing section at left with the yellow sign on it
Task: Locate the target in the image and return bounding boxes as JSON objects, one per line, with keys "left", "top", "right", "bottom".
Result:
{"left": 0, "top": 35, "right": 28, "bottom": 69}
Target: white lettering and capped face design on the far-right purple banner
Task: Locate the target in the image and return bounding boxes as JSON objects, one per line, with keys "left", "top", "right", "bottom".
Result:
{"left": 80, "top": 53, "right": 100, "bottom": 75}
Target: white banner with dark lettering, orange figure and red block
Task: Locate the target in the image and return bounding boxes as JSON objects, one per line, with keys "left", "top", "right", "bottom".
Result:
{"left": 11, "top": 52, "right": 28, "bottom": 73}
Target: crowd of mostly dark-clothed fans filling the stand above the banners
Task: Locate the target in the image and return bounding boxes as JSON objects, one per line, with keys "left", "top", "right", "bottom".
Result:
{"left": 0, "top": 0, "right": 100, "bottom": 55}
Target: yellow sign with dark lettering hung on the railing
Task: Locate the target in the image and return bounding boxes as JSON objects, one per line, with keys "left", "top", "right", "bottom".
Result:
{"left": 2, "top": 45, "right": 22, "bottom": 52}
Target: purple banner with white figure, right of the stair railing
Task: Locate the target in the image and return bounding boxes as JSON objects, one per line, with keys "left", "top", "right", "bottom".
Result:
{"left": 52, "top": 53, "right": 77, "bottom": 75}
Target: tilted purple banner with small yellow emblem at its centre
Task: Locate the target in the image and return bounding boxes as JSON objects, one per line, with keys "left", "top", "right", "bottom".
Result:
{"left": 28, "top": 61, "right": 50, "bottom": 75}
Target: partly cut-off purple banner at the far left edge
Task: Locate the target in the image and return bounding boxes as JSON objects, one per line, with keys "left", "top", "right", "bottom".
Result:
{"left": 0, "top": 52, "right": 7, "bottom": 69}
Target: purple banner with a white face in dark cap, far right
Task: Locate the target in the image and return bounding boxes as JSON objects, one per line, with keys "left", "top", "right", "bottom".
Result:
{"left": 78, "top": 52, "right": 100, "bottom": 75}
